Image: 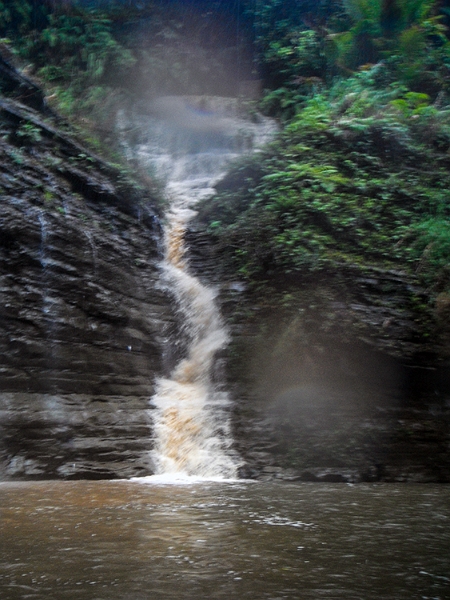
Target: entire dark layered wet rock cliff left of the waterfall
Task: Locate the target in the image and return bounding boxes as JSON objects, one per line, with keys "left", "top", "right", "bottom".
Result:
{"left": 0, "top": 72, "right": 174, "bottom": 478}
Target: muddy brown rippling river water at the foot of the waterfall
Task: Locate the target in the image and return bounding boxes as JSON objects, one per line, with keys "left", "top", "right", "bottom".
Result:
{"left": 0, "top": 479, "right": 450, "bottom": 600}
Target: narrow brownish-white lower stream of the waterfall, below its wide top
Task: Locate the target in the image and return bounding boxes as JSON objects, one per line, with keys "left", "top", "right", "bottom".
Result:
{"left": 152, "top": 205, "right": 237, "bottom": 477}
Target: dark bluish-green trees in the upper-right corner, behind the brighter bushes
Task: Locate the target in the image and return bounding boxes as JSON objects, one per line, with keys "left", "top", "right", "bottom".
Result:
{"left": 250, "top": 0, "right": 450, "bottom": 120}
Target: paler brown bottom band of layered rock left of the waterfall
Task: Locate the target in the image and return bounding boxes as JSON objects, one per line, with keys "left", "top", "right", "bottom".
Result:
{"left": 0, "top": 392, "right": 156, "bottom": 479}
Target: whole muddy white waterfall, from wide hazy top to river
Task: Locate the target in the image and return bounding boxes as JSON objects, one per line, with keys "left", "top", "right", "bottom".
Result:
{"left": 119, "top": 97, "right": 275, "bottom": 478}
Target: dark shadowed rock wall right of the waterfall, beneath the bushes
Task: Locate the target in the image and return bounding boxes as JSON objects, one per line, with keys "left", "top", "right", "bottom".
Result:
{"left": 188, "top": 226, "right": 450, "bottom": 482}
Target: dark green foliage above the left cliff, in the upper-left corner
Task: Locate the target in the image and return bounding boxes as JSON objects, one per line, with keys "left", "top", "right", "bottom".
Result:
{"left": 0, "top": 0, "right": 135, "bottom": 135}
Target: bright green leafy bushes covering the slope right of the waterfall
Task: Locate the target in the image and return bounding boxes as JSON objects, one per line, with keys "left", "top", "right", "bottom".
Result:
{"left": 200, "top": 70, "right": 450, "bottom": 292}
